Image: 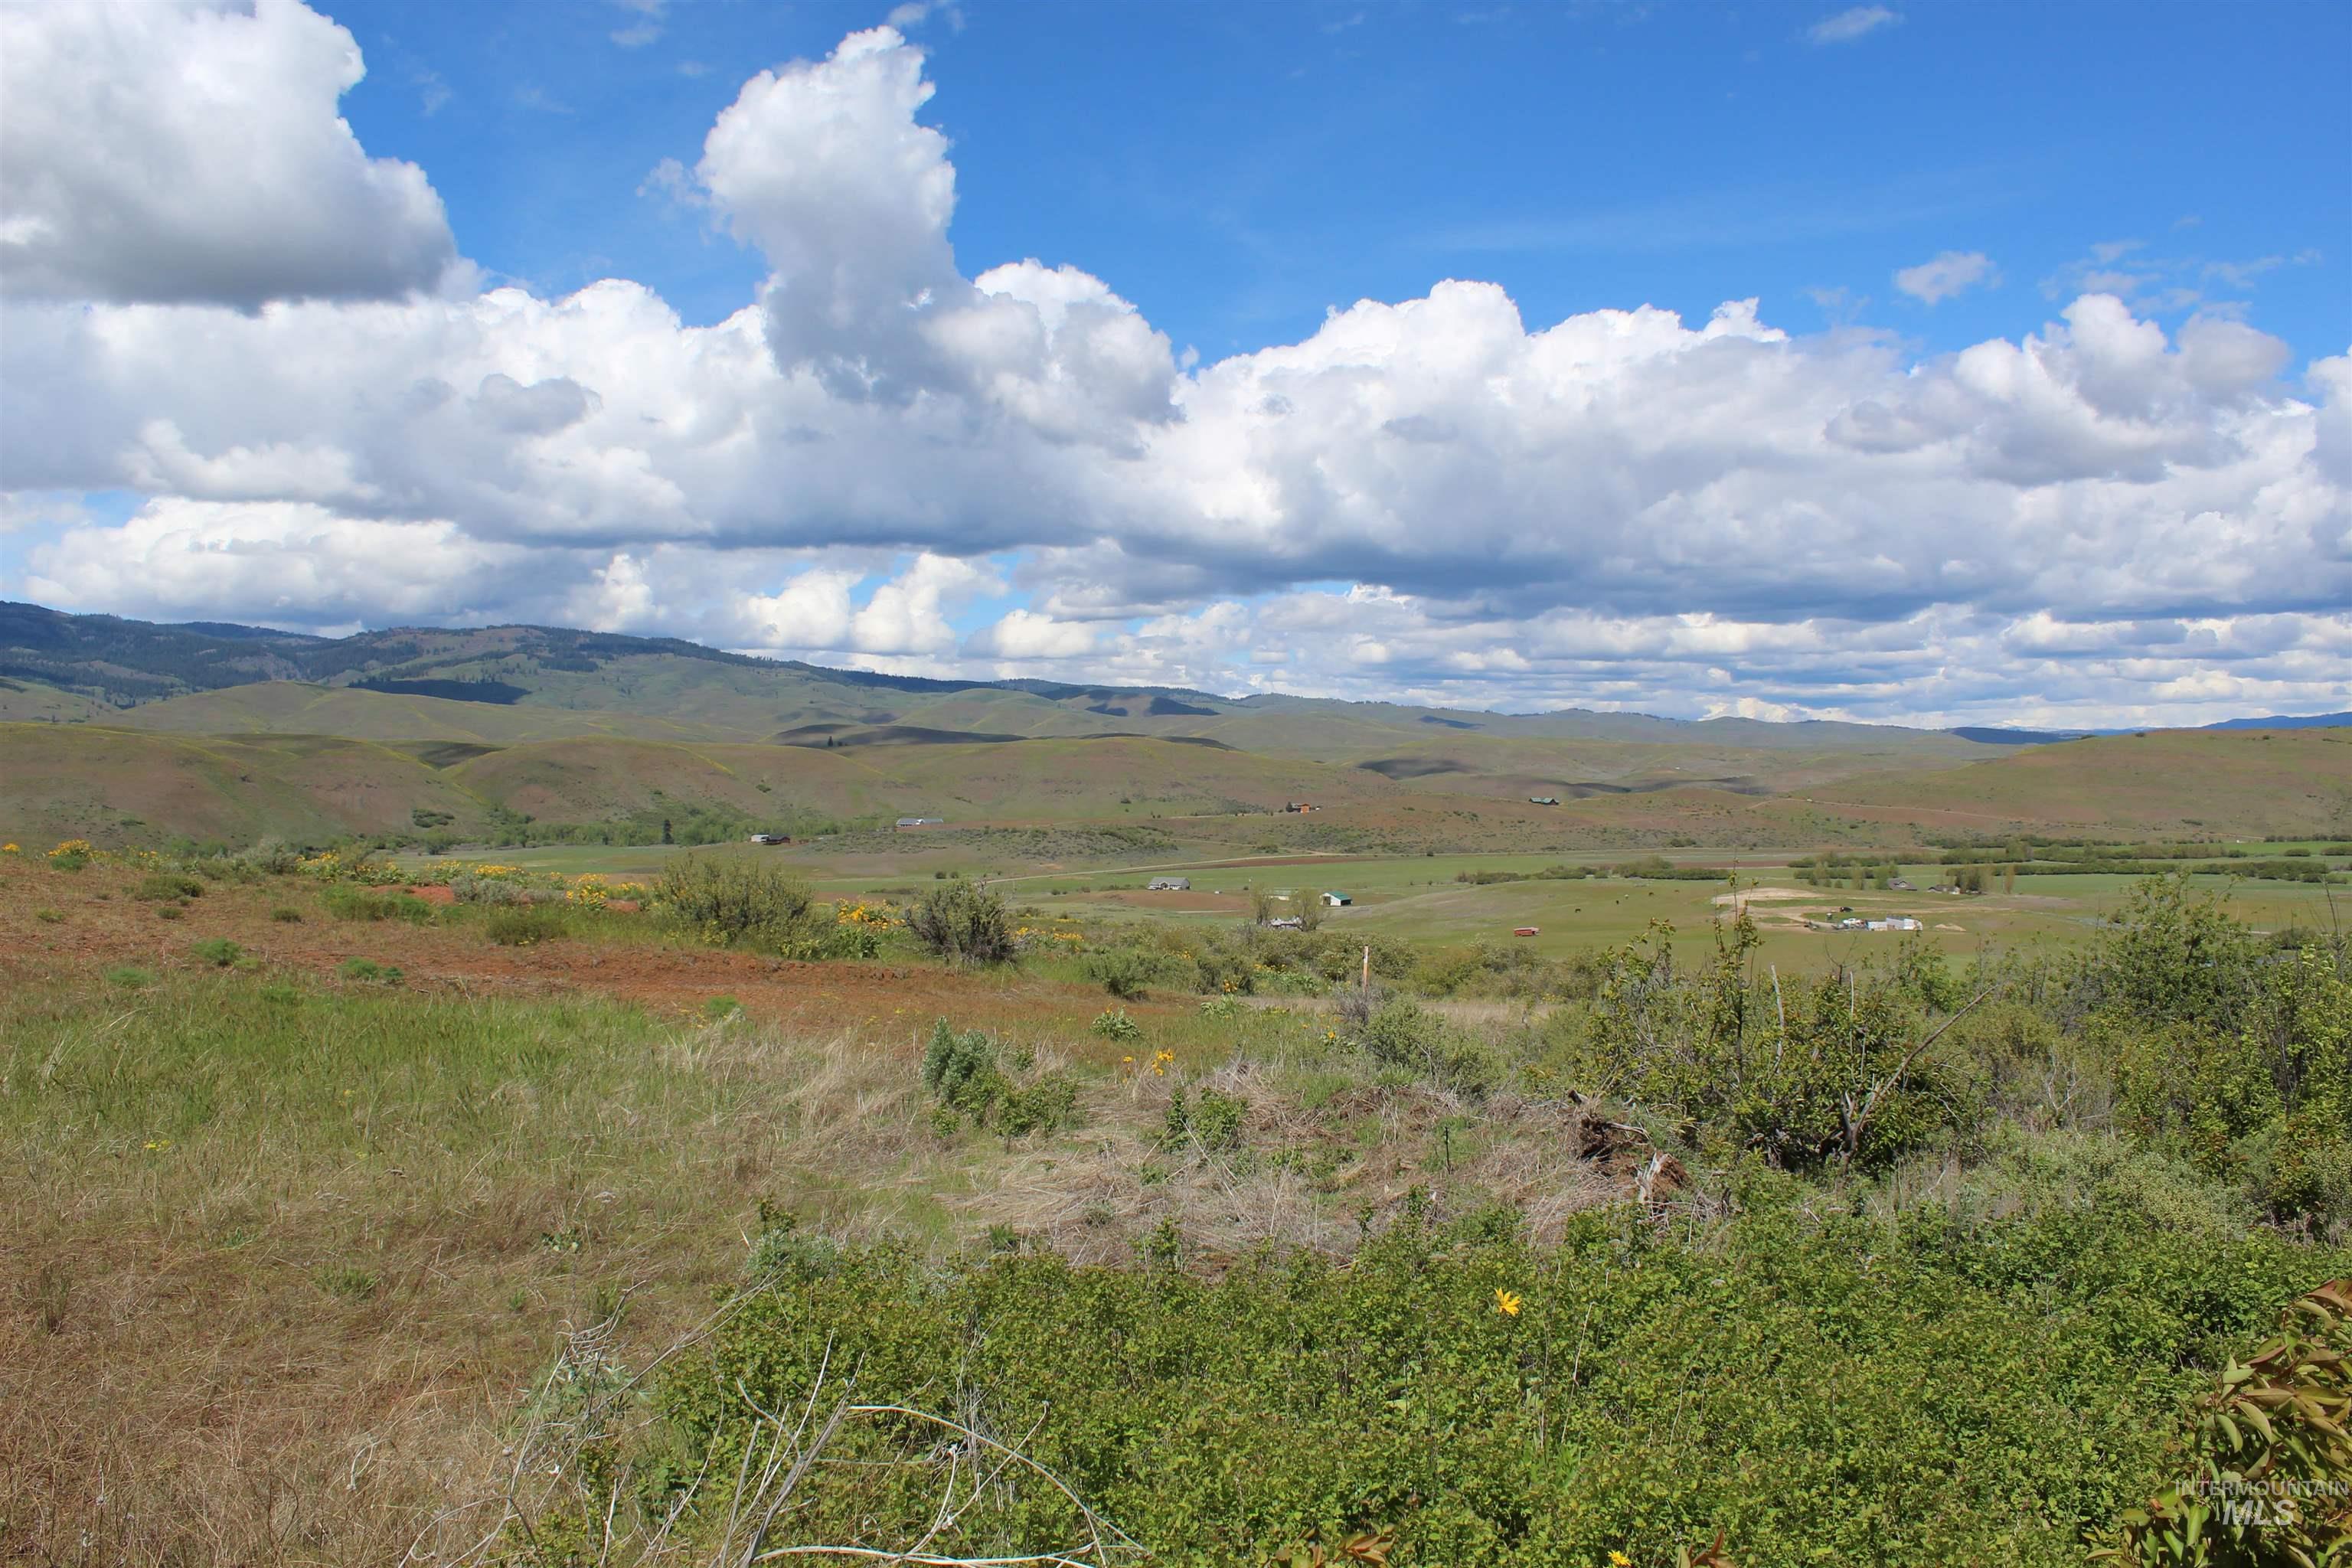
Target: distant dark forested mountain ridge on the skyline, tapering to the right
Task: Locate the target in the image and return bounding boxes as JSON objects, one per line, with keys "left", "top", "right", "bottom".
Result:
{"left": 0, "top": 604, "right": 2013, "bottom": 771}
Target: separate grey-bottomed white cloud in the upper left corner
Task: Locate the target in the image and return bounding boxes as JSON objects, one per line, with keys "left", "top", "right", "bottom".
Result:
{"left": 0, "top": 0, "right": 456, "bottom": 308}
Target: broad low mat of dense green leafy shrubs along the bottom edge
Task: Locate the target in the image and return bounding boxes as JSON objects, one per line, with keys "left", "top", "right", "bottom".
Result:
{"left": 656, "top": 1182, "right": 2343, "bottom": 1568}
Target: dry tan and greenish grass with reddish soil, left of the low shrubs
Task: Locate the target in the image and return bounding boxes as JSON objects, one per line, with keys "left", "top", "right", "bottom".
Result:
{"left": 0, "top": 870, "right": 1623, "bottom": 1568}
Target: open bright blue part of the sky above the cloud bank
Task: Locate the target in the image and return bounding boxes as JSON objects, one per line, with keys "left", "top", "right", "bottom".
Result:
{"left": 320, "top": 0, "right": 2352, "bottom": 358}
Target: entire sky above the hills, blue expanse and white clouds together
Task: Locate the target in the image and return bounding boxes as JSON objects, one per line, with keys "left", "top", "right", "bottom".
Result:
{"left": 0, "top": 0, "right": 2352, "bottom": 724}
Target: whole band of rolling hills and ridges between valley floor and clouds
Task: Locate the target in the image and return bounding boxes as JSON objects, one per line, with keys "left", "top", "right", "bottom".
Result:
{"left": 0, "top": 604, "right": 2352, "bottom": 848}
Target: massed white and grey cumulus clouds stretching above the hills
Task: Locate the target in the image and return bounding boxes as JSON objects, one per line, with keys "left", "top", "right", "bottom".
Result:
{"left": 0, "top": 11, "right": 2352, "bottom": 720}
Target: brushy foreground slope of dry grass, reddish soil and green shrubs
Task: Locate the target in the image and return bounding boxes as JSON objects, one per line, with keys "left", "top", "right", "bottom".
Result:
{"left": 0, "top": 848, "right": 2352, "bottom": 1568}
